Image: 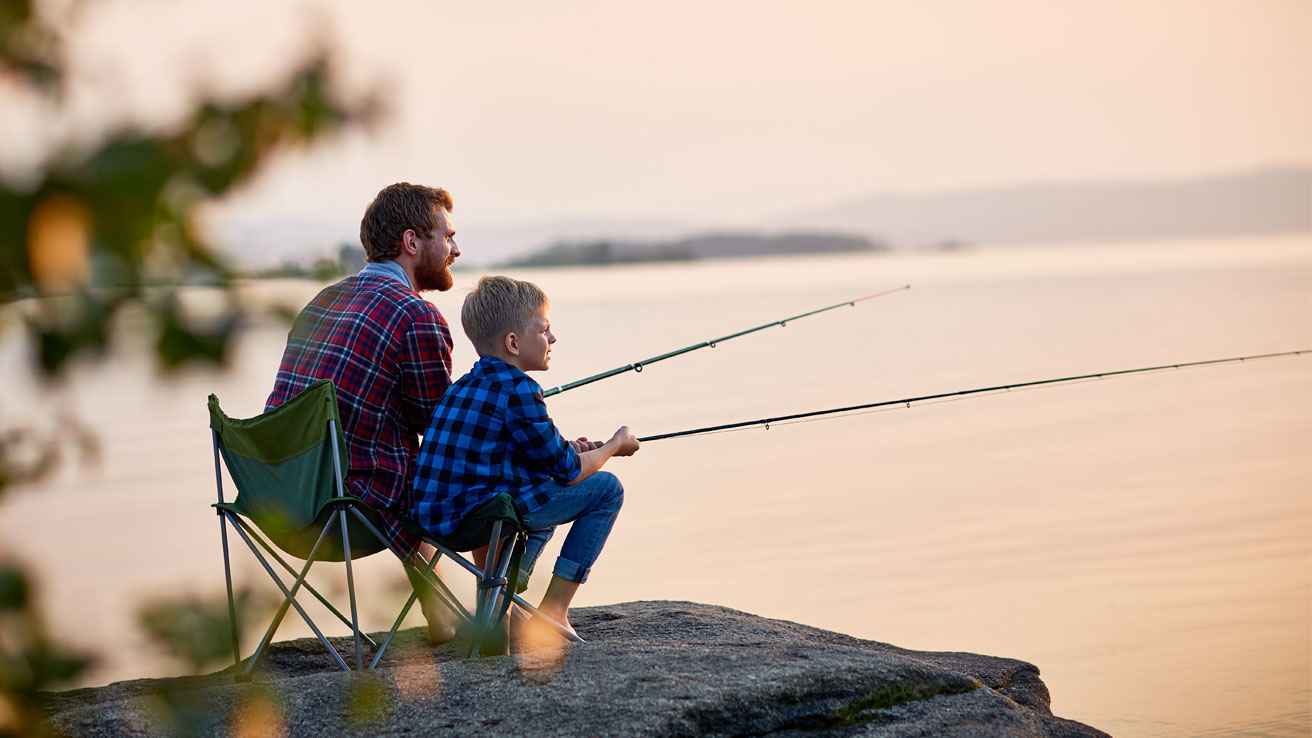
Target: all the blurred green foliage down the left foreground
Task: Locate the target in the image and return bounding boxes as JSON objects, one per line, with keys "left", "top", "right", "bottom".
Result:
{"left": 0, "top": 0, "right": 377, "bottom": 738}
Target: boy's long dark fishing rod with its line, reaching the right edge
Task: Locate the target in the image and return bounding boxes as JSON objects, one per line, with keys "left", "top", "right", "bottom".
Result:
{"left": 638, "top": 349, "right": 1312, "bottom": 443}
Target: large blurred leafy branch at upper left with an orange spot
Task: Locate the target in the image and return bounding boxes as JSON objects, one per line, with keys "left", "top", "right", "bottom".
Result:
{"left": 0, "top": 13, "right": 375, "bottom": 373}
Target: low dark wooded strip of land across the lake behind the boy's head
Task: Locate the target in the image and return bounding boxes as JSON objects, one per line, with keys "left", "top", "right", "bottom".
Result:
{"left": 506, "top": 232, "right": 886, "bottom": 267}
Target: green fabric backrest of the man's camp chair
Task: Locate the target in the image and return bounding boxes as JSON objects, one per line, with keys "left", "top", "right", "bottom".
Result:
{"left": 209, "top": 380, "right": 364, "bottom": 558}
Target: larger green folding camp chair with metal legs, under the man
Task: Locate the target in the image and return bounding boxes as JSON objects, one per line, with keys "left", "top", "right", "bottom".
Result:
{"left": 209, "top": 380, "right": 472, "bottom": 680}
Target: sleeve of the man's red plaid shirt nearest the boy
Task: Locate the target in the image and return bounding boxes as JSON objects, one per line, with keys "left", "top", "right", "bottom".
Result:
{"left": 399, "top": 303, "right": 451, "bottom": 436}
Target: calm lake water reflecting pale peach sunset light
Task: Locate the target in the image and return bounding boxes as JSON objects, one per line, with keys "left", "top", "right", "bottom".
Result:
{"left": 0, "top": 235, "right": 1312, "bottom": 737}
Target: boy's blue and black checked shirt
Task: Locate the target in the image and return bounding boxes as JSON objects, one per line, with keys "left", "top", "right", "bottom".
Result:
{"left": 415, "top": 356, "right": 580, "bottom": 536}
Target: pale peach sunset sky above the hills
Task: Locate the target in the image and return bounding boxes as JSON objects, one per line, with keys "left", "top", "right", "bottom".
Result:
{"left": 0, "top": 0, "right": 1312, "bottom": 244}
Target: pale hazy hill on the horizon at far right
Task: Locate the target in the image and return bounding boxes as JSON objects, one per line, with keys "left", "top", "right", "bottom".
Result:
{"left": 781, "top": 168, "right": 1312, "bottom": 247}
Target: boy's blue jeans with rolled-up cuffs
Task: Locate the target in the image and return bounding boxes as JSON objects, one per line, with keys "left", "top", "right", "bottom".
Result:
{"left": 521, "top": 471, "right": 625, "bottom": 584}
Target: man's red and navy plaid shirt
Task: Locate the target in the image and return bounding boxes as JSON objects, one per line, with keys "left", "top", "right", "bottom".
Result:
{"left": 265, "top": 267, "right": 451, "bottom": 554}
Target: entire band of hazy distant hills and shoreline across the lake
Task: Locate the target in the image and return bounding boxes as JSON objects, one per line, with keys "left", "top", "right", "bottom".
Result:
{"left": 216, "top": 167, "right": 1312, "bottom": 269}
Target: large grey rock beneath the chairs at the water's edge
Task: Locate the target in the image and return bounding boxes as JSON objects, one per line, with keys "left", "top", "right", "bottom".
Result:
{"left": 45, "top": 601, "right": 1106, "bottom": 738}
